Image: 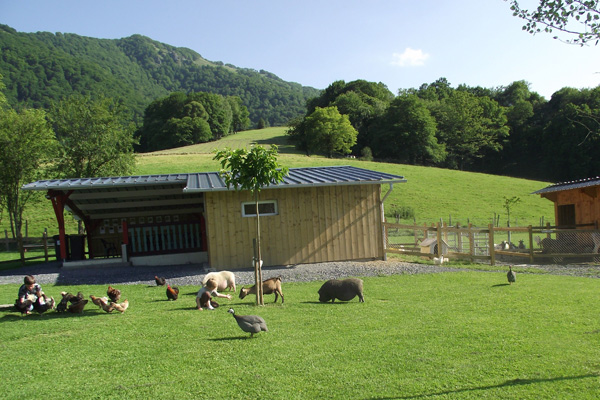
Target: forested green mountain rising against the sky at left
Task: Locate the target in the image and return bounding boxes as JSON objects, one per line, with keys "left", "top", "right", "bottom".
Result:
{"left": 0, "top": 25, "right": 319, "bottom": 126}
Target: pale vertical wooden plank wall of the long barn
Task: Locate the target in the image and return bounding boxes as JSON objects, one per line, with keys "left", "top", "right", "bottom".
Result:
{"left": 205, "top": 185, "right": 383, "bottom": 269}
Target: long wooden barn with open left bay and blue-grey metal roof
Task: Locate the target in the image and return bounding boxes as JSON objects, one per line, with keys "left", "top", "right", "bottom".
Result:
{"left": 23, "top": 166, "right": 406, "bottom": 269}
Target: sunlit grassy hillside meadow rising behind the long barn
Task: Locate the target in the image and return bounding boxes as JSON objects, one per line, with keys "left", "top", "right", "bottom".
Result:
{"left": 1, "top": 127, "right": 554, "bottom": 241}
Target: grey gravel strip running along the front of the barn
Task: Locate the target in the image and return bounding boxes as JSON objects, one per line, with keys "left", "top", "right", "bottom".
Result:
{"left": 0, "top": 261, "right": 600, "bottom": 286}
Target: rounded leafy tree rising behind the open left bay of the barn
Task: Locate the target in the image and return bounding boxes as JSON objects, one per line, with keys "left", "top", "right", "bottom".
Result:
{"left": 49, "top": 95, "right": 135, "bottom": 178}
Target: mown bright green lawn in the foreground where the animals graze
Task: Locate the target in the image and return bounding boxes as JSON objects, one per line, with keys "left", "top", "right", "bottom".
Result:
{"left": 0, "top": 272, "right": 600, "bottom": 399}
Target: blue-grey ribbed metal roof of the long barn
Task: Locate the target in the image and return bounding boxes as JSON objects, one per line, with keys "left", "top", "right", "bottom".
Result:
{"left": 23, "top": 166, "right": 406, "bottom": 219}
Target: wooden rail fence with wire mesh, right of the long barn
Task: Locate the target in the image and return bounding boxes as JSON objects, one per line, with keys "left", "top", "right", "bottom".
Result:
{"left": 384, "top": 223, "right": 600, "bottom": 265}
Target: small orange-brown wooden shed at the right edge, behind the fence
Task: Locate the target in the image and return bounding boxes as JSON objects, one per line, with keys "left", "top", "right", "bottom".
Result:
{"left": 534, "top": 177, "right": 600, "bottom": 229}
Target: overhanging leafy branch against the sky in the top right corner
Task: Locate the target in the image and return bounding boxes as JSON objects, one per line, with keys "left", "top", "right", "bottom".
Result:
{"left": 510, "top": 0, "right": 600, "bottom": 46}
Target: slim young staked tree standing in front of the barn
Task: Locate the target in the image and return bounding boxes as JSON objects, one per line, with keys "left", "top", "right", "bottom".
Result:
{"left": 214, "top": 145, "right": 288, "bottom": 305}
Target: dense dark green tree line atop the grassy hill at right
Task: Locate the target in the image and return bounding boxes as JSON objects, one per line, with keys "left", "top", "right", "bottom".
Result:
{"left": 288, "top": 78, "right": 600, "bottom": 181}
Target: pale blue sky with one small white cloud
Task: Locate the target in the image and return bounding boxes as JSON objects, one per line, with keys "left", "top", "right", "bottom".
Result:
{"left": 0, "top": 0, "right": 600, "bottom": 99}
